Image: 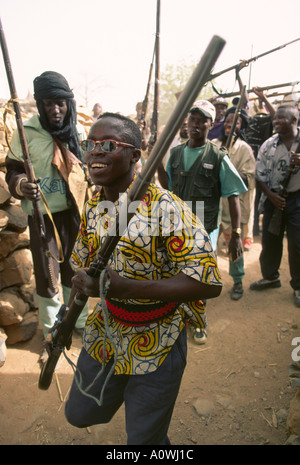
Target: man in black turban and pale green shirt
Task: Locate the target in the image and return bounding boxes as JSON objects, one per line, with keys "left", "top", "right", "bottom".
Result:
{"left": 6, "top": 71, "right": 87, "bottom": 361}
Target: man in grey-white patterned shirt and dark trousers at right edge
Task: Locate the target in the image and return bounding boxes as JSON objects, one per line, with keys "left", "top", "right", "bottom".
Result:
{"left": 250, "top": 105, "right": 300, "bottom": 307}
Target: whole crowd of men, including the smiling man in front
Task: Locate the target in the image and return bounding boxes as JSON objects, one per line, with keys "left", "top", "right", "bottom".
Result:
{"left": 6, "top": 71, "right": 300, "bottom": 445}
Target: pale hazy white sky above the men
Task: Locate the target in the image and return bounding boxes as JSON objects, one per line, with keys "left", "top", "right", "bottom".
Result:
{"left": 0, "top": 0, "right": 300, "bottom": 114}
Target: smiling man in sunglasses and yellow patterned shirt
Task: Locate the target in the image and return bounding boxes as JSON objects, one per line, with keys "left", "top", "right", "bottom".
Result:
{"left": 65, "top": 113, "right": 222, "bottom": 445}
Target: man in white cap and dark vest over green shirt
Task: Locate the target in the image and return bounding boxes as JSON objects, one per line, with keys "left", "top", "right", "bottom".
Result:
{"left": 158, "top": 100, "right": 247, "bottom": 344}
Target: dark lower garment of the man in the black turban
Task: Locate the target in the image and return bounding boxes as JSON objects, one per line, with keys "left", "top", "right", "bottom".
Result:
{"left": 28, "top": 209, "right": 79, "bottom": 297}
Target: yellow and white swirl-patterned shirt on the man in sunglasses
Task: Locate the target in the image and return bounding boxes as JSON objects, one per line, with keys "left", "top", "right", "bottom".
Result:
{"left": 71, "top": 184, "right": 222, "bottom": 374}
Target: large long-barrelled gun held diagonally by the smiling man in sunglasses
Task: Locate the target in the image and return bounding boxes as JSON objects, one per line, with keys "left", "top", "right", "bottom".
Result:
{"left": 39, "top": 36, "right": 225, "bottom": 390}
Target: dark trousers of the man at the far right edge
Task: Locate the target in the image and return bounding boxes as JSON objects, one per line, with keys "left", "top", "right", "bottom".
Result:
{"left": 260, "top": 191, "right": 300, "bottom": 289}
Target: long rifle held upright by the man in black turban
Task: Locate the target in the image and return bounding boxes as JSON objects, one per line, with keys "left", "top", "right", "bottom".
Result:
{"left": 0, "top": 19, "right": 58, "bottom": 292}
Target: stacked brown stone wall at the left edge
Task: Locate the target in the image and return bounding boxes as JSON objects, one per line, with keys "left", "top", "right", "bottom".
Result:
{"left": 0, "top": 171, "right": 38, "bottom": 344}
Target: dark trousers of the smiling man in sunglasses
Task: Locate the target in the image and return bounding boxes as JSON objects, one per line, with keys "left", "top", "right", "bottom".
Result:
{"left": 65, "top": 328, "right": 187, "bottom": 445}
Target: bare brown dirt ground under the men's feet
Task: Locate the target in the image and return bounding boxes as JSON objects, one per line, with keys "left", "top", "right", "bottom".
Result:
{"left": 0, "top": 237, "right": 300, "bottom": 446}
